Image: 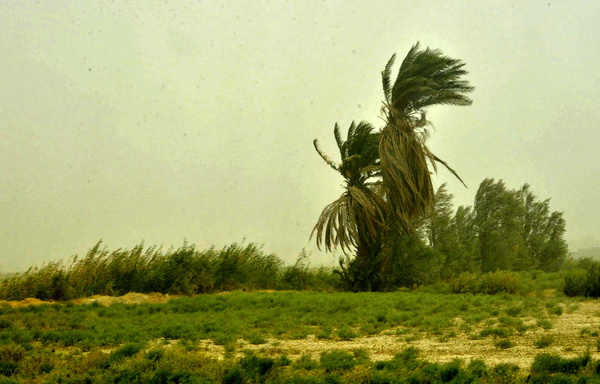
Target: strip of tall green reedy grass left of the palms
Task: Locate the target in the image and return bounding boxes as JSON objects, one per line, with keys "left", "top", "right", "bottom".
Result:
{"left": 0, "top": 241, "right": 338, "bottom": 300}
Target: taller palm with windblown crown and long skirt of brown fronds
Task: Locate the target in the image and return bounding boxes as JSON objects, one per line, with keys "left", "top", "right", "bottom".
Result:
{"left": 379, "top": 43, "right": 474, "bottom": 234}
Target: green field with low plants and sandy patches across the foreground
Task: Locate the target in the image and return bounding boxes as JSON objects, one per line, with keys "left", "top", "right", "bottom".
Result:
{"left": 0, "top": 290, "right": 600, "bottom": 383}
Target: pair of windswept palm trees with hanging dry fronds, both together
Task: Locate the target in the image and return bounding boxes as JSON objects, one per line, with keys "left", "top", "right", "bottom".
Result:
{"left": 311, "top": 43, "right": 473, "bottom": 290}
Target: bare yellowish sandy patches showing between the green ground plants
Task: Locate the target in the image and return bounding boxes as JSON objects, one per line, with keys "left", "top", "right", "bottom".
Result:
{"left": 0, "top": 293, "right": 600, "bottom": 370}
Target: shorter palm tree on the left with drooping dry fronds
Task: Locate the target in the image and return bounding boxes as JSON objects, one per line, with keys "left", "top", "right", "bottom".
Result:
{"left": 311, "top": 122, "right": 389, "bottom": 290}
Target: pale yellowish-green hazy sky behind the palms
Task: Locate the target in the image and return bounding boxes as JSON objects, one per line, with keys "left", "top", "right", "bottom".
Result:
{"left": 0, "top": 0, "right": 600, "bottom": 272}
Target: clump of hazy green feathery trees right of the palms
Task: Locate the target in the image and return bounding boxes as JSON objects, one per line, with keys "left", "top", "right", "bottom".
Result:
{"left": 421, "top": 179, "right": 568, "bottom": 275}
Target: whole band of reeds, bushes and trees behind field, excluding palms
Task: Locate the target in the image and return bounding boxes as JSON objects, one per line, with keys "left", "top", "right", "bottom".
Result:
{"left": 0, "top": 179, "right": 584, "bottom": 300}
